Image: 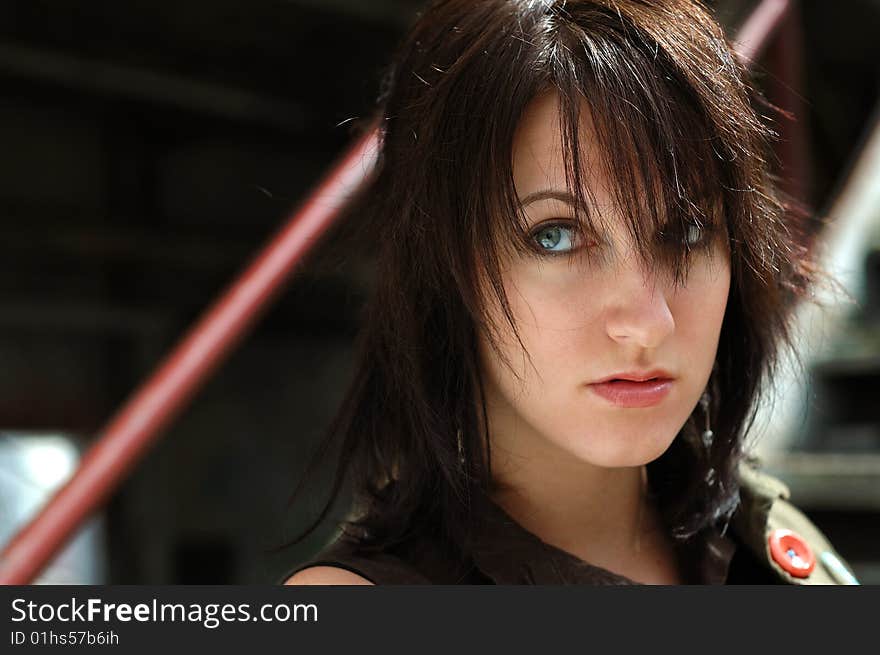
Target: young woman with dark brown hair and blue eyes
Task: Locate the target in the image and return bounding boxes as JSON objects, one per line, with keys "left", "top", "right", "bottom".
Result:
{"left": 276, "top": 0, "right": 851, "bottom": 584}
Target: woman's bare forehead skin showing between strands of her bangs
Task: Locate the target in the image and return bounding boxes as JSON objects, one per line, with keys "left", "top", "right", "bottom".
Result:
{"left": 512, "top": 91, "right": 610, "bottom": 206}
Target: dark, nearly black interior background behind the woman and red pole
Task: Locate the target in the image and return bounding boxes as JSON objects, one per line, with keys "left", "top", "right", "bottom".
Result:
{"left": 0, "top": 0, "right": 880, "bottom": 584}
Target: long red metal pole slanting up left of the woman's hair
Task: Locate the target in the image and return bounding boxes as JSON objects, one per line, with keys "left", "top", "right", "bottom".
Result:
{"left": 0, "top": 129, "right": 377, "bottom": 584}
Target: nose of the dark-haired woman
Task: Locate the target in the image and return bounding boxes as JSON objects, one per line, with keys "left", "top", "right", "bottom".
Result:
{"left": 606, "top": 257, "right": 675, "bottom": 349}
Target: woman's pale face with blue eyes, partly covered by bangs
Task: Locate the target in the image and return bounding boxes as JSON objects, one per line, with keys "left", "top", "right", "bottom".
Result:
{"left": 480, "top": 93, "right": 730, "bottom": 470}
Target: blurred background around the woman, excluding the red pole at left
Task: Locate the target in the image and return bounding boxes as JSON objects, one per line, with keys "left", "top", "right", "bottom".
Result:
{"left": 0, "top": 0, "right": 880, "bottom": 584}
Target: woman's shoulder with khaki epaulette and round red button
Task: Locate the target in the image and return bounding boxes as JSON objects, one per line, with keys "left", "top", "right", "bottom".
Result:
{"left": 732, "top": 457, "right": 858, "bottom": 585}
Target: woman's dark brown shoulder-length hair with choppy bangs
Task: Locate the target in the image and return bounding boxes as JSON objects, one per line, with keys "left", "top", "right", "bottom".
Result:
{"left": 280, "top": 0, "right": 813, "bottom": 556}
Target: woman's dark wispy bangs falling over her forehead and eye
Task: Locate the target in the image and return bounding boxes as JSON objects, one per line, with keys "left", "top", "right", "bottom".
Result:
{"left": 478, "top": 5, "right": 735, "bottom": 292}
